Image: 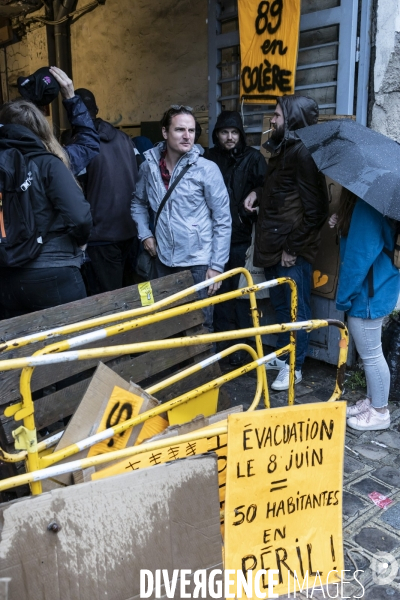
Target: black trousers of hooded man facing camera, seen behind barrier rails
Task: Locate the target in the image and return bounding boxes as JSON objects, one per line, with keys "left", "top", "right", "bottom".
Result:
{"left": 214, "top": 243, "right": 251, "bottom": 346}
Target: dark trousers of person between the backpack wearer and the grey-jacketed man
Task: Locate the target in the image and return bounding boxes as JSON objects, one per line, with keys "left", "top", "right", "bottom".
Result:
{"left": 83, "top": 238, "right": 134, "bottom": 296}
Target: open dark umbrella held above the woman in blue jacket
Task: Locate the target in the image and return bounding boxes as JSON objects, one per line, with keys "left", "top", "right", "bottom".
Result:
{"left": 296, "top": 119, "right": 400, "bottom": 220}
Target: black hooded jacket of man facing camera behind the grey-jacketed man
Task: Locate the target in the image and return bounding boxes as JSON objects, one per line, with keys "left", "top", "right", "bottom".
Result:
{"left": 204, "top": 110, "right": 267, "bottom": 244}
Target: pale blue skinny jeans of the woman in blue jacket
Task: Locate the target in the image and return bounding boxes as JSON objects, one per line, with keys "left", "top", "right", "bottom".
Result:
{"left": 347, "top": 316, "right": 390, "bottom": 408}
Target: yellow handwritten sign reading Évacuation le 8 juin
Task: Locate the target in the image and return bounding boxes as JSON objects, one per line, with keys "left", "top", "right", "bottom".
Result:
{"left": 225, "top": 402, "right": 346, "bottom": 597}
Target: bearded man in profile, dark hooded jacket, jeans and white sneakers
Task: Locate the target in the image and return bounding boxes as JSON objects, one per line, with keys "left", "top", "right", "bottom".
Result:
{"left": 245, "top": 94, "right": 329, "bottom": 391}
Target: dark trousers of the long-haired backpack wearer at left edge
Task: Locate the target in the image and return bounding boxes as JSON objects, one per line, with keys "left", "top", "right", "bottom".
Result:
{"left": 0, "top": 267, "right": 86, "bottom": 318}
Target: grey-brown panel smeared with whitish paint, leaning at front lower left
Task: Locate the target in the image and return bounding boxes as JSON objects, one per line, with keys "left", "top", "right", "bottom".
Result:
{"left": 0, "top": 456, "right": 222, "bottom": 600}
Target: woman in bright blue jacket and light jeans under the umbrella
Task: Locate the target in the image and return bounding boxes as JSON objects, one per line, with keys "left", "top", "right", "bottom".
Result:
{"left": 329, "top": 188, "right": 400, "bottom": 431}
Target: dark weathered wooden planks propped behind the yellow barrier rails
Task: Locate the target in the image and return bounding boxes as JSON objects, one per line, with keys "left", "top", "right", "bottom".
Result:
{"left": 0, "top": 272, "right": 225, "bottom": 446}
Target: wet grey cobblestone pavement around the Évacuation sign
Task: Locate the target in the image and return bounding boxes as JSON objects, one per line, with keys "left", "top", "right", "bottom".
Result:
{"left": 221, "top": 352, "right": 400, "bottom": 600}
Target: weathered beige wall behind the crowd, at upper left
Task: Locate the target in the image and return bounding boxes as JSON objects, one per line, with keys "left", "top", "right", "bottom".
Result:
{"left": 0, "top": 0, "right": 208, "bottom": 131}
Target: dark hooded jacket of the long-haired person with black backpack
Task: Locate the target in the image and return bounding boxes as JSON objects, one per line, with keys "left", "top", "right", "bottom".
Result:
{"left": 0, "top": 125, "right": 92, "bottom": 268}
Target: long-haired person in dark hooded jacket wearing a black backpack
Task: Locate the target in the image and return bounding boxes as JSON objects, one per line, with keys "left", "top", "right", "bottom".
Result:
{"left": 0, "top": 99, "right": 92, "bottom": 318}
